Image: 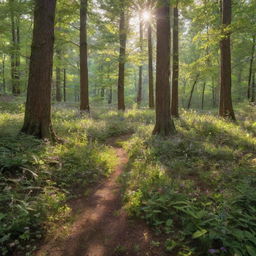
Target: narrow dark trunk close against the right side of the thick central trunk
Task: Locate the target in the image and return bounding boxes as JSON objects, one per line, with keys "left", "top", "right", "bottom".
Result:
{"left": 171, "top": 6, "right": 179, "bottom": 117}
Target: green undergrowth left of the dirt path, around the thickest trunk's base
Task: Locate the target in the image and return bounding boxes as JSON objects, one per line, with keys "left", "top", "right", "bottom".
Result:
{"left": 0, "top": 103, "right": 120, "bottom": 255}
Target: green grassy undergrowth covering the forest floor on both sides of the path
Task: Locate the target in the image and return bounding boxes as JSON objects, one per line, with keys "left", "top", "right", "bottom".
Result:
{"left": 0, "top": 99, "right": 256, "bottom": 256}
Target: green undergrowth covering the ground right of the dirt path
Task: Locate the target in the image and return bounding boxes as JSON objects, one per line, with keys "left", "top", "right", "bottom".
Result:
{"left": 122, "top": 107, "right": 256, "bottom": 256}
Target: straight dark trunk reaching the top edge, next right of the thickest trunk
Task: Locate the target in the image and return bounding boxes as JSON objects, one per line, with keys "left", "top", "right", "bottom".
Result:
{"left": 80, "top": 0, "right": 90, "bottom": 112}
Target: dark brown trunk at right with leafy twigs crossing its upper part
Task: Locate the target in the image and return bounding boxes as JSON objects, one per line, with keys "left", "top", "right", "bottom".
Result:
{"left": 219, "top": 0, "right": 235, "bottom": 120}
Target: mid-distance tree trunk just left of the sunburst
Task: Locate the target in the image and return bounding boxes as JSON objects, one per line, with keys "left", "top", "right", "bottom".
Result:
{"left": 117, "top": 7, "right": 127, "bottom": 111}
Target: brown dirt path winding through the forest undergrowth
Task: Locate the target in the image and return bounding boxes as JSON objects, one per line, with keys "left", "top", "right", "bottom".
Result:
{"left": 35, "top": 137, "right": 164, "bottom": 256}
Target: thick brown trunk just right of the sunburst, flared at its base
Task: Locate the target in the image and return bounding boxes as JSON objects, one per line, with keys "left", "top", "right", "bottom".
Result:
{"left": 153, "top": 0, "right": 175, "bottom": 136}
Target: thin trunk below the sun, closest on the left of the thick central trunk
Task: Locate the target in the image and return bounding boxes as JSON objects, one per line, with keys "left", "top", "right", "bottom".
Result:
{"left": 148, "top": 23, "right": 155, "bottom": 109}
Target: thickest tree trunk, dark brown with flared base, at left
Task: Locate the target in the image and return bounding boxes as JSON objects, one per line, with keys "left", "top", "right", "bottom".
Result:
{"left": 22, "top": 0, "right": 56, "bottom": 140}
